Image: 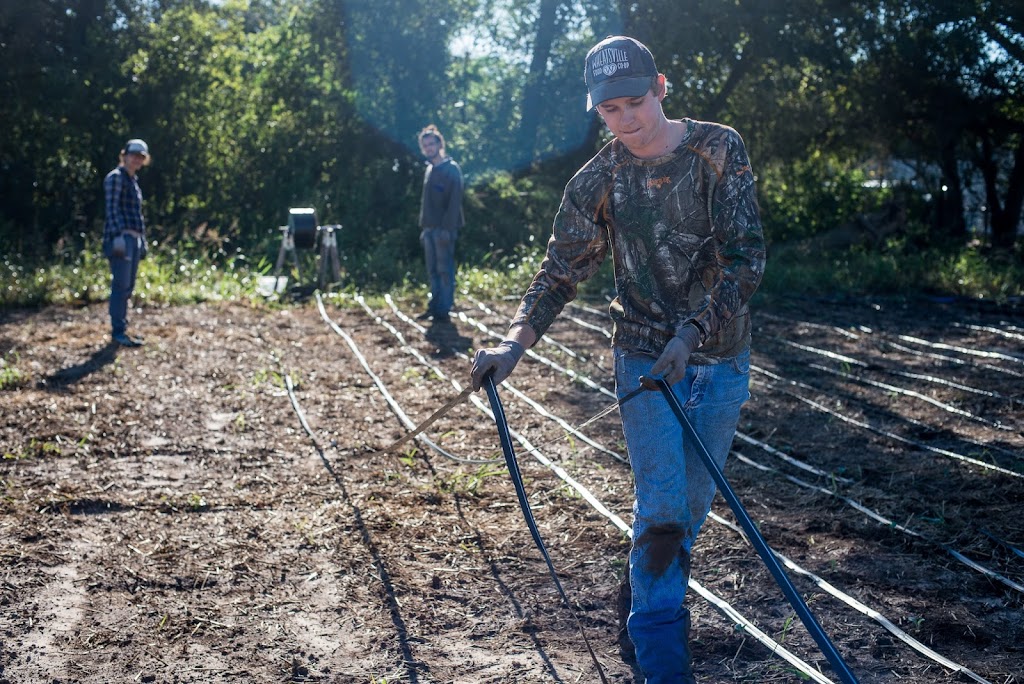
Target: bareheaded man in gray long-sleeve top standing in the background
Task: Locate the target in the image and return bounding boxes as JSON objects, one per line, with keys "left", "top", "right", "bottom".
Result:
{"left": 418, "top": 124, "right": 465, "bottom": 322}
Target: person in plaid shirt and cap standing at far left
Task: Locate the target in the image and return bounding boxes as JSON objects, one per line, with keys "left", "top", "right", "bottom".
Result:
{"left": 102, "top": 138, "right": 150, "bottom": 347}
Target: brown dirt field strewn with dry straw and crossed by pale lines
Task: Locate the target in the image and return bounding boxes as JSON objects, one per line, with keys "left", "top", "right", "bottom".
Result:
{"left": 0, "top": 290, "right": 1024, "bottom": 684}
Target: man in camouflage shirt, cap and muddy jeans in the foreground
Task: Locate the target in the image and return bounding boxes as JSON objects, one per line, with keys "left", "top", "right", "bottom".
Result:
{"left": 471, "top": 36, "right": 765, "bottom": 684}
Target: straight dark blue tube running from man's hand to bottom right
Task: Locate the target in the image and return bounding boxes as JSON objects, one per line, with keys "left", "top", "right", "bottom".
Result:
{"left": 640, "top": 377, "right": 857, "bottom": 684}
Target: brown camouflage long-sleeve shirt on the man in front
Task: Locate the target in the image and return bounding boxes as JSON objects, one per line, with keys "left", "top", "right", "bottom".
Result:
{"left": 511, "top": 119, "right": 765, "bottom": 364}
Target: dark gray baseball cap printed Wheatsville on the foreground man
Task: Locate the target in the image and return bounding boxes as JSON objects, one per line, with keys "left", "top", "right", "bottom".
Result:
{"left": 584, "top": 36, "right": 657, "bottom": 112}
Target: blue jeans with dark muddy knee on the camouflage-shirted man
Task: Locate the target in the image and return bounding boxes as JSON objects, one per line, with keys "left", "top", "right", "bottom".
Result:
{"left": 615, "top": 350, "right": 751, "bottom": 684}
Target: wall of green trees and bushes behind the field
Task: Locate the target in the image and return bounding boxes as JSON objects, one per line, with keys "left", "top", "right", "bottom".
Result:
{"left": 0, "top": 0, "right": 1024, "bottom": 305}
